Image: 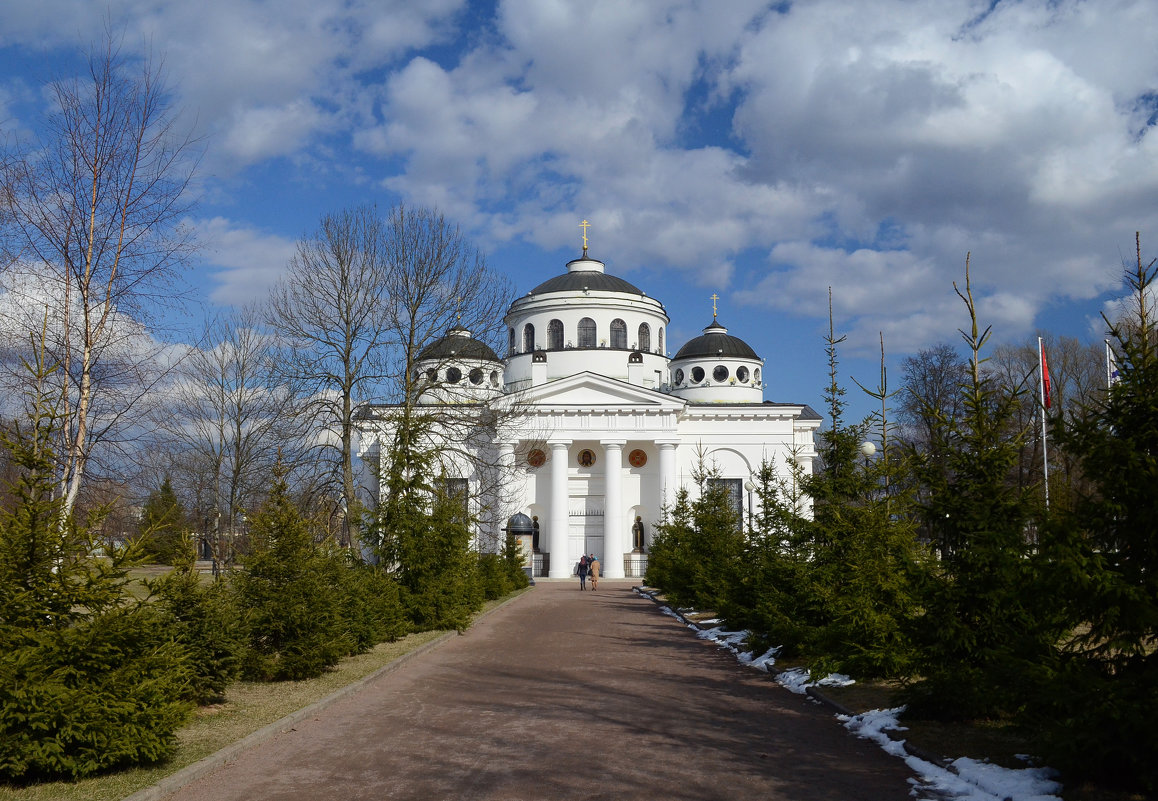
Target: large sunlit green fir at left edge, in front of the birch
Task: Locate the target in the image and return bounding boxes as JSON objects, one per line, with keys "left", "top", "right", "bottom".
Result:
{"left": 0, "top": 354, "right": 189, "bottom": 782}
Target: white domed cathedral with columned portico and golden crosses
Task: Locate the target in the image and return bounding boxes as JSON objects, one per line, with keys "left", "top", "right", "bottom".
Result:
{"left": 360, "top": 237, "right": 821, "bottom": 579}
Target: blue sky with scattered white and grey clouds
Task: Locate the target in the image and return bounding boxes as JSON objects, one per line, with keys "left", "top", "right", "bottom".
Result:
{"left": 0, "top": 0, "right": 1158, "bottom": 419}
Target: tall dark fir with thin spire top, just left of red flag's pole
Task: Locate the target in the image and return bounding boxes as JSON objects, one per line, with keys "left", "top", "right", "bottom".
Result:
{"left": 906, "top": 258, "right": 1057, "bottom": 719}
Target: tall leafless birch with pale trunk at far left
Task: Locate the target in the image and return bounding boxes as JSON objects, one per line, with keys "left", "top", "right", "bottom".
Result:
{"left": 0, "top": 34, "right": 192, "bottom": 513}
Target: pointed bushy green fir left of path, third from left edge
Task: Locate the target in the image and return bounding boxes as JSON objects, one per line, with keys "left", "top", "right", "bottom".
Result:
{"left": 234, "top": 465, "right": 353, "bottom": 681}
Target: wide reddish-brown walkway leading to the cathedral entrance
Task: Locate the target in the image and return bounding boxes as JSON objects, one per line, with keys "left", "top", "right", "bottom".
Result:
{"left": 160, "top": 580, "right": 911, "bottom": 801}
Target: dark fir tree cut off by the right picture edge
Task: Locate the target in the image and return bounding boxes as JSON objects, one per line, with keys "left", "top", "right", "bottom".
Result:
{"left": 1032, "top": 231, "right": 1158, "bottom": 792}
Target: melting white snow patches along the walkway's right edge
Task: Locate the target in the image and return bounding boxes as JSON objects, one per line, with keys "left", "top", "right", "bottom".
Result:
{"left": 637, "top": 590, "right": 1062, "bottom": 801}
